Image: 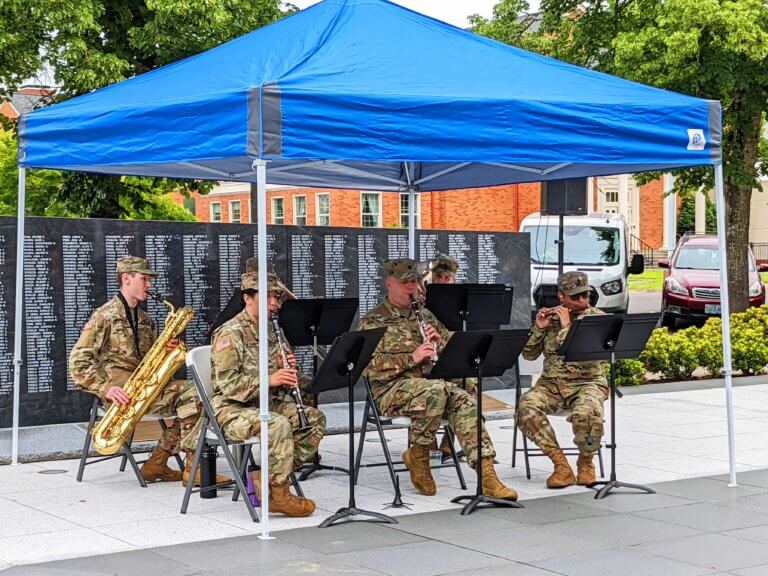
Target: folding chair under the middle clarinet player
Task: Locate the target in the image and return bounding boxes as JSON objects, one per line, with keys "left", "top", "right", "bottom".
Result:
{"left": 350, "top": 378, "right": 467, "bottom": 503}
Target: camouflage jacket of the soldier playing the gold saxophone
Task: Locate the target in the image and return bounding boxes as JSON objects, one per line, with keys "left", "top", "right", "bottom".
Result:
{"left": 69, "top": 296, "right": 157, "bottom": 398}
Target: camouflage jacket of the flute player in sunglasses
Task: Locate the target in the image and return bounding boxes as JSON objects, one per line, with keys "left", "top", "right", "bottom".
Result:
{"left": 523, "top": 308, "right": 607, "bottom": 386}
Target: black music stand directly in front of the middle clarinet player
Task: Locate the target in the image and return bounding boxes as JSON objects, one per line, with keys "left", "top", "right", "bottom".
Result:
{"left": 427, "top": 329, "right": 528, "bottom": 516}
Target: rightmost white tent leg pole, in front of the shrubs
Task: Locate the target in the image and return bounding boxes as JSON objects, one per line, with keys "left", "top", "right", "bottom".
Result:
{"left": 715, "top": 164, "right": 737, "bottom": 487}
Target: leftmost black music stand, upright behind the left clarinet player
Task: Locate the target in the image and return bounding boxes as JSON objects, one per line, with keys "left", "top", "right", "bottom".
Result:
{"left": 279, "top": 298, "right": 360, "bottom": 482}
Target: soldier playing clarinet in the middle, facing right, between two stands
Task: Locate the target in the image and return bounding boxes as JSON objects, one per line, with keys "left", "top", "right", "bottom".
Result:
{"left": 360, "top": 259, "right": 517, "bottom": 500}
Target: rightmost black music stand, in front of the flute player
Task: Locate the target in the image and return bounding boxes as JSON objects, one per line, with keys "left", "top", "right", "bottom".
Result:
{"left": 560, "top": 312, "right": 660, "bottom": 500}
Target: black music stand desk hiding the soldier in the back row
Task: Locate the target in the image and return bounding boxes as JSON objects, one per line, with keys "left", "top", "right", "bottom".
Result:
{"left": 425, "top": 284, "right": 513, "bottom": 332}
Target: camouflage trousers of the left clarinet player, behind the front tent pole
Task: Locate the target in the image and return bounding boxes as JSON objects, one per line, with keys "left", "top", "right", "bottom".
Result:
{"left": 213, "top": 401, "right": 325, "bottom": 484}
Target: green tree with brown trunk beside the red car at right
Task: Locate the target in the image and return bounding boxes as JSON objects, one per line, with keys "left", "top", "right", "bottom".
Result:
{"left": 473, "top": 0, "right": 768, "bottom": 311}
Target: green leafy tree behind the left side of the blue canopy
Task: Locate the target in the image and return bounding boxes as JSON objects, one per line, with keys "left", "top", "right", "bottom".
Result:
{"left": 0, "top": 0, "right": 295, "bottom": 219}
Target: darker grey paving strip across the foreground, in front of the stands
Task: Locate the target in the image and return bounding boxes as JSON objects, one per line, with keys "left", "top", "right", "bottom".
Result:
{"left": 3, "top": 470, "right": 768, "bottom": 576}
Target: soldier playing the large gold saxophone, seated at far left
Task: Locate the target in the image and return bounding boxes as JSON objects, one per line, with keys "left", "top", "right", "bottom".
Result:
{"left": 69, "top": 256, "right": 228, "bottom": 485}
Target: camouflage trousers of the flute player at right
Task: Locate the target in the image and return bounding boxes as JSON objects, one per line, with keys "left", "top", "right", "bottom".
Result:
{"left": 517, "top": 378, "right": 608, "bottom": 456}
